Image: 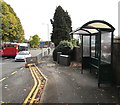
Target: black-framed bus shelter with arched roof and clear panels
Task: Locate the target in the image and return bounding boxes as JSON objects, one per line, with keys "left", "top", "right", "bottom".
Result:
{"left": 70, "top": 20, "right": 115, "bottom": 87}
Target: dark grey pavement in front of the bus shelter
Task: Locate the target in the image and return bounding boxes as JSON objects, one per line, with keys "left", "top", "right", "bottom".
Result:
{"left": 38, "top": 55, "right": 120, "bottom": 103}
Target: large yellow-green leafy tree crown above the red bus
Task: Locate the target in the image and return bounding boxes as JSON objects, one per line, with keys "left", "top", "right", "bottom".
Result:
{"left": 0, "top": 0, "right": 24, "bottom": 42}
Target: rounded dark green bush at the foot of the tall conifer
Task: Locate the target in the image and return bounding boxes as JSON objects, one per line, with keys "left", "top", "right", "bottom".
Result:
{"left": 53, "top": 40, "right": 73, "bottom": 61}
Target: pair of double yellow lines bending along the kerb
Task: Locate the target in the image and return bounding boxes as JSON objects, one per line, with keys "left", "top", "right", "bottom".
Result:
{"left": 23, "top": 65, "right": 46, "bottom": 105}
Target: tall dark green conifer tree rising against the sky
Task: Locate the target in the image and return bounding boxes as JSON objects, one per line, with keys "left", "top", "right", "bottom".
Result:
{"left": 51, "top": 6, "right": 72, "bottom": 46}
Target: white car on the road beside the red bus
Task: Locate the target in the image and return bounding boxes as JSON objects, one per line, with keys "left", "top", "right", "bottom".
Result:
{"left": 15, "top": 51, "right": 31, "bottom": 61}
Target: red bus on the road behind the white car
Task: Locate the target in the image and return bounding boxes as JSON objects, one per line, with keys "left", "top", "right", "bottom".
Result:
{"left": 2, "top": 44, "right": 19, "bottom": 57}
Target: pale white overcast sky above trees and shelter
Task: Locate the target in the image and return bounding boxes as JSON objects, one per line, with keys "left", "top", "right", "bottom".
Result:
{"left": 4, "top": 0, "right": 119, "bottom": 41}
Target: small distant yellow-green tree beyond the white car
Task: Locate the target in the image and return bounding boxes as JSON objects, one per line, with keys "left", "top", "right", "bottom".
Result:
{"left": 30, "top": 34, "right": 40, "bottom": 48}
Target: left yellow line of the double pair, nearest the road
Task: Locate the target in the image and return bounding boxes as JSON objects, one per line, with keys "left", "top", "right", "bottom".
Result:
{"left": 23, "top": 67, "right": 37, "bottom": 105}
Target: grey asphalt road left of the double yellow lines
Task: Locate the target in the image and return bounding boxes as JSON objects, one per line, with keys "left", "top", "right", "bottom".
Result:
{"left": 0, "top": 49, "right": 41, "bottom": 103}
